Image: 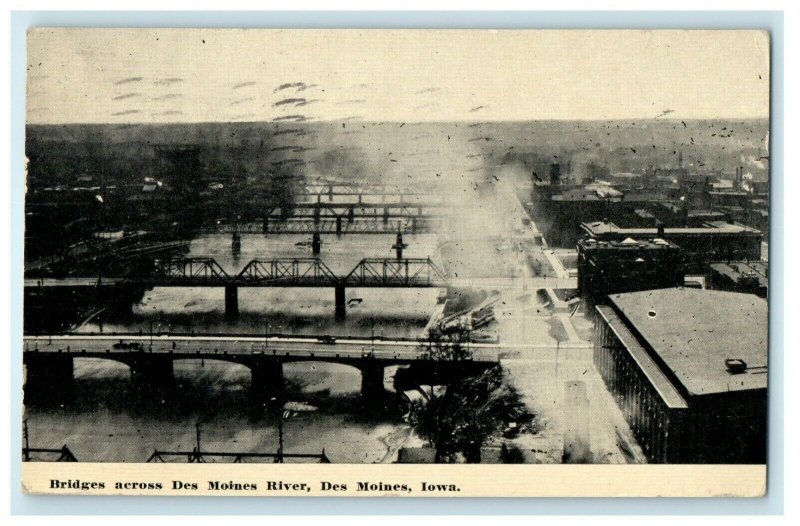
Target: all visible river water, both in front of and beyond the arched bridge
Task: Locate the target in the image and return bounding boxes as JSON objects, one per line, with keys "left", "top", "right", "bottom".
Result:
{"left": 26, "top": 234, "right": 446, "bottom": 463}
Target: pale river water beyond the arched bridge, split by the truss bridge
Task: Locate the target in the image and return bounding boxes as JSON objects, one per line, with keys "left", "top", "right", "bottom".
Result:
{"left": 78, "top": 234, "right": 442, "bottom": 338}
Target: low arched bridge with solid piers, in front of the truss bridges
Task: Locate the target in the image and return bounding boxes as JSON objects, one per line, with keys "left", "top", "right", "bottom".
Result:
{"left": 23, "top": 334, "right": 500, "bottom": 401}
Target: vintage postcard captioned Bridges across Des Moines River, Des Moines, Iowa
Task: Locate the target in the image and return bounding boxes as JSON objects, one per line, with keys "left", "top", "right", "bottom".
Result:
{"left": 20, "top": 28, "right": 770, "bottom": 497}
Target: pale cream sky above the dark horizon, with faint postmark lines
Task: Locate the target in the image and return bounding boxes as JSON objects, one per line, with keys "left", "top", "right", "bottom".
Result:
{"left": 26, "top": 28, "right": 769, "bottom": 124}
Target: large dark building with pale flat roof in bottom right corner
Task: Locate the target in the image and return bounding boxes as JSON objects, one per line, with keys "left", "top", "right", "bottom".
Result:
{"left": 594, "top": 288, "right": 767, "bottom": 464}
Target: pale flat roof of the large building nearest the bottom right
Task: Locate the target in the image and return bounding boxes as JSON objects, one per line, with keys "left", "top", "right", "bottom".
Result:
{"left": 609, "top": 288, "right": 768, "bottom": 396}
